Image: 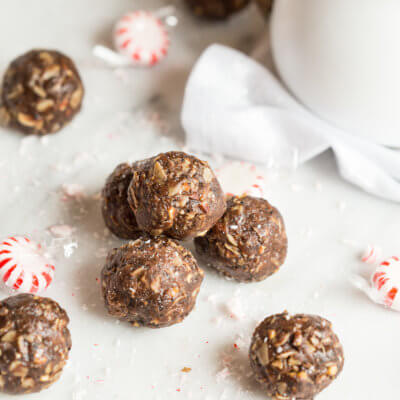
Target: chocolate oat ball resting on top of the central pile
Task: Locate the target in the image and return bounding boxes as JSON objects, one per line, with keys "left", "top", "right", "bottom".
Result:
{"left": 128, "top": 151, "right": 226, "bottom": 240}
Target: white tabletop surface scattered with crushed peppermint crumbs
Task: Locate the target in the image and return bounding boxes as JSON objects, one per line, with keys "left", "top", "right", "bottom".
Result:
{"left": 0, "top": 0, "right": 400, "bottom": 400}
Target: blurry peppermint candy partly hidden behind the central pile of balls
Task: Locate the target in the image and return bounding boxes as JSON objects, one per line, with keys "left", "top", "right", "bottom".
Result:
{"left": 215, "top": 161, "right": 266, "bottom": 198}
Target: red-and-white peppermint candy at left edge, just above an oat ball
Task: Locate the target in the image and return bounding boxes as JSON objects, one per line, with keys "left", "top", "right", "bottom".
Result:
{"left": 0, "top": 236, "right": 55, "bottom": 293}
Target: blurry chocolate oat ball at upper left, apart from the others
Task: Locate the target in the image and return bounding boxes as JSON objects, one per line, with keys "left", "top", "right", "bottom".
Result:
{"left": 0, "top": 50, "right": 84, "bottom": 135}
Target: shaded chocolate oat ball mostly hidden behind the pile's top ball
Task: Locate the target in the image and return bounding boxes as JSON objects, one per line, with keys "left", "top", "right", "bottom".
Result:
{"left": 101, "top": 163, "right": 141, "bottom": 239}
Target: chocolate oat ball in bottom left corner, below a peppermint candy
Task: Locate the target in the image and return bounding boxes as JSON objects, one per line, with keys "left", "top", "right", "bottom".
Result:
{"left": 0, "top": 294, "right": 71, "bottom": 394}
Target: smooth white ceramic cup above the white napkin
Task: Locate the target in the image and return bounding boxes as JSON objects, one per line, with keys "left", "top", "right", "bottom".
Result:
{"left": 271, "top": 0, "right": 400, "bottom": 147}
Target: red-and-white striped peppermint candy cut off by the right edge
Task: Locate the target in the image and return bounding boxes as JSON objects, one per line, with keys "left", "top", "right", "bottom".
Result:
{"left": 372, "top": 256, "right": 400, "bottom": 311}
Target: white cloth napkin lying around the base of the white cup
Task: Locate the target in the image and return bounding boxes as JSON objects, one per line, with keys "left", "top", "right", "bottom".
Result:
{"left": 182, "top": 45, "right": 400, "bottom": 201}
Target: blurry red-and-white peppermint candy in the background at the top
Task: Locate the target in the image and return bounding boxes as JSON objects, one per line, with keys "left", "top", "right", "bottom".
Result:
{"left": 114, "top": 11, "right": 169, "bottom": 66}
